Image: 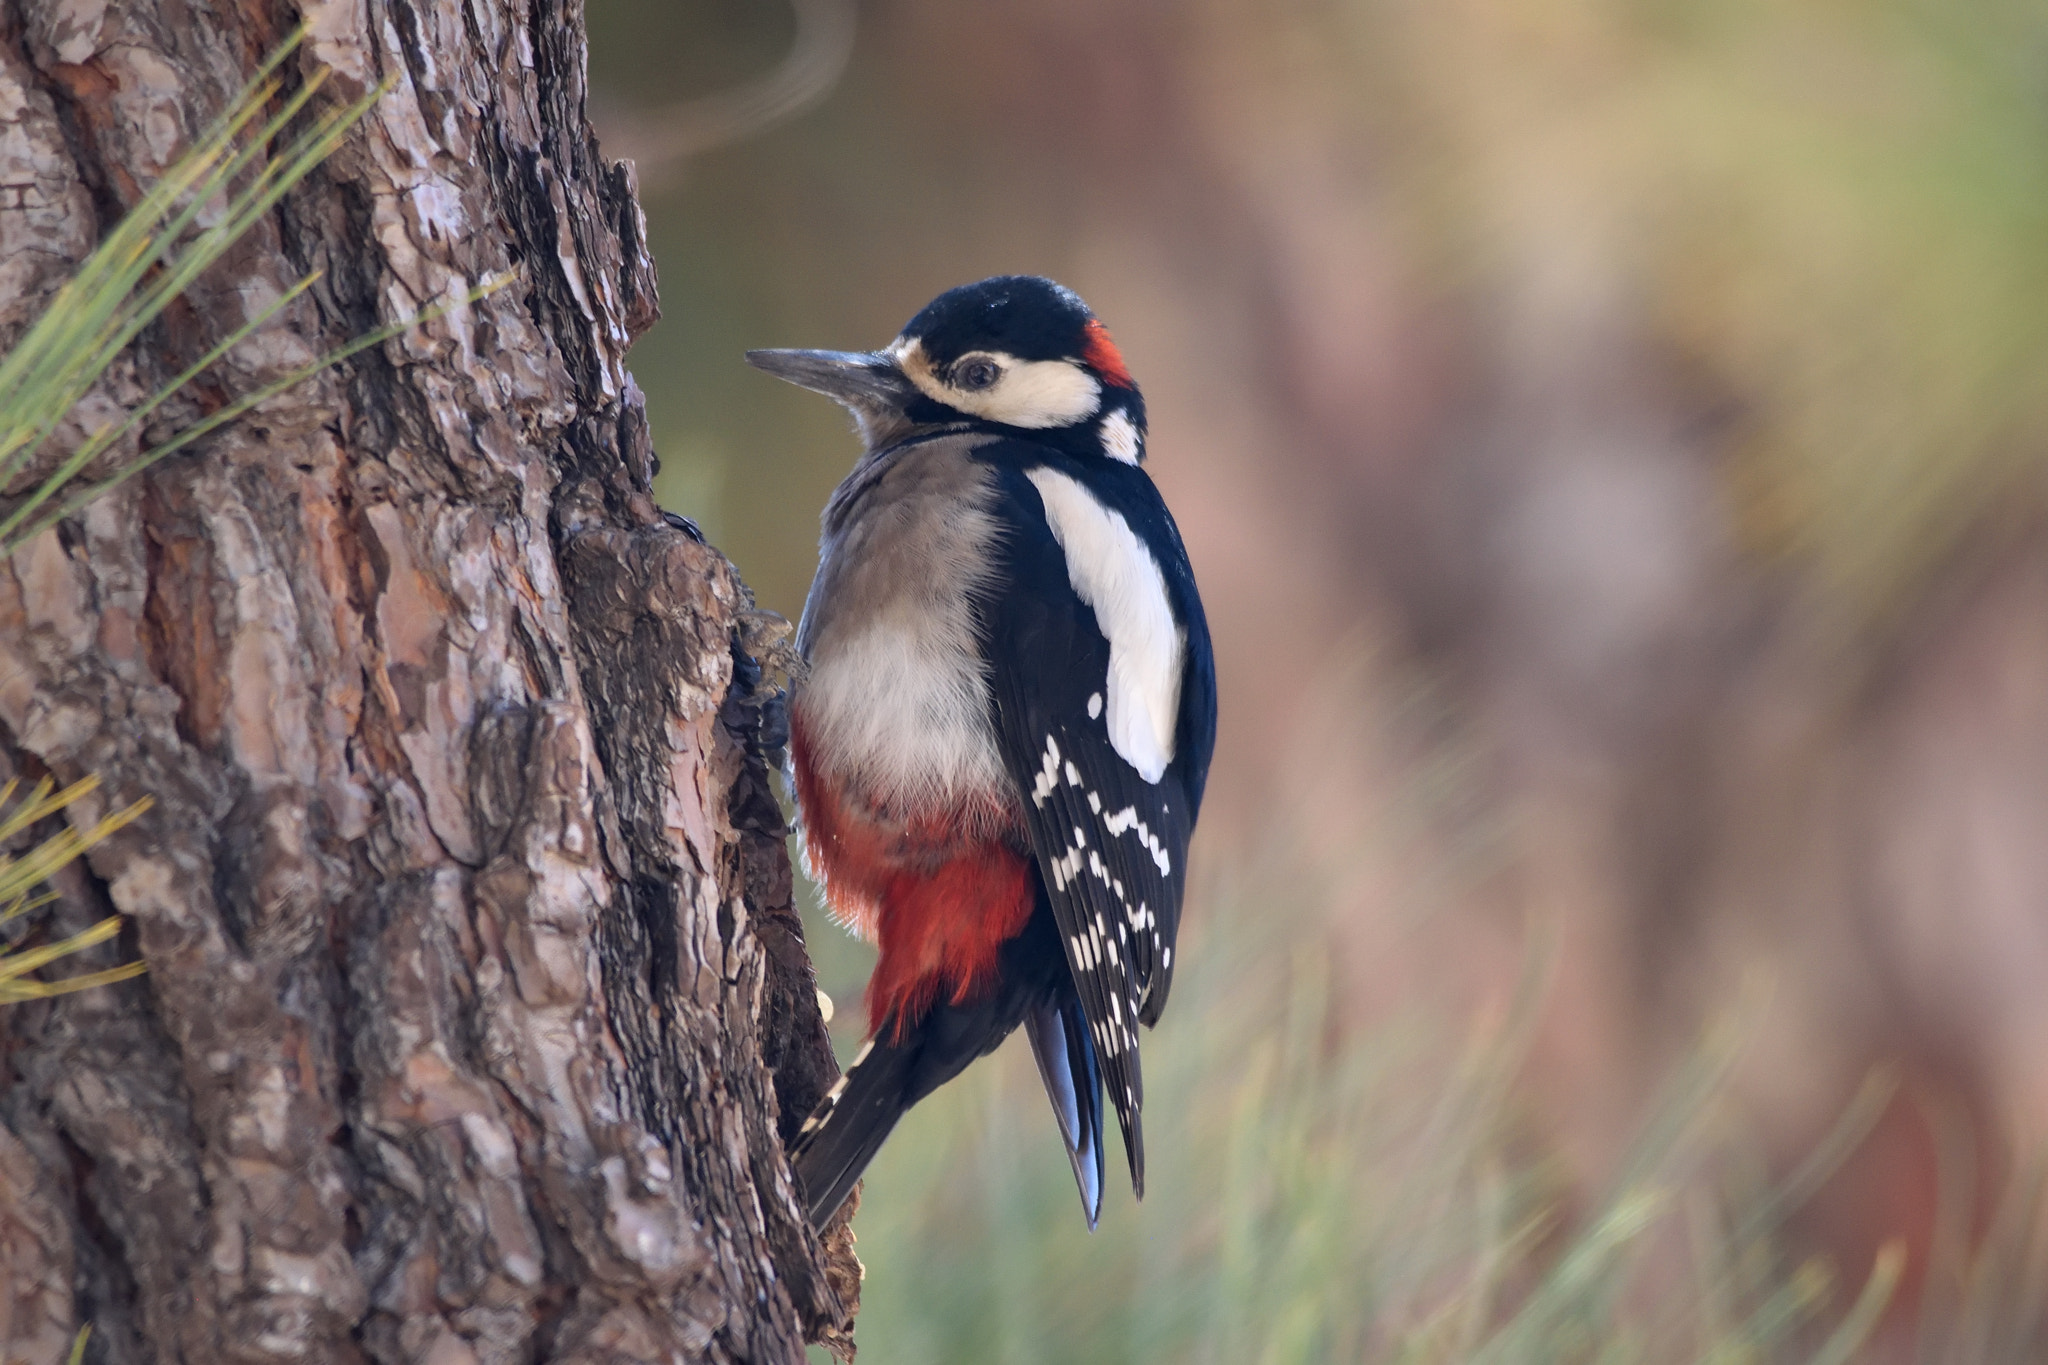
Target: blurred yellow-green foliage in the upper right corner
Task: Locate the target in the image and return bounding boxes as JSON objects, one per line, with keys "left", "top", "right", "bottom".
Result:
{"left": 1376, "top": 0, "right": 2048, "bottom": 622}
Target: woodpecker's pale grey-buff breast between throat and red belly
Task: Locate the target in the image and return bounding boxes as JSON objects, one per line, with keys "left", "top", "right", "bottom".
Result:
{"left": 795, "top": 436, "right": 1008, "bottom": 814}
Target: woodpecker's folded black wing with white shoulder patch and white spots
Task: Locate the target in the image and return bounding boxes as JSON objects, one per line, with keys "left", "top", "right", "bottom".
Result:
{"left": 983, "top": 450, "right": 1208, "bottom": 1191}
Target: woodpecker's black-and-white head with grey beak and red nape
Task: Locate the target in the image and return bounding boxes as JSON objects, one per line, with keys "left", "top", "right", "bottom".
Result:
{"left": 748, "top": 274, "right": 1145, "bottom": 465}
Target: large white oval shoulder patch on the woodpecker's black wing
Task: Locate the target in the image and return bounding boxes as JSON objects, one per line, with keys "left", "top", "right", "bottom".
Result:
{"left": 1026, "top": 469, "right": 1188, "bottom": 782}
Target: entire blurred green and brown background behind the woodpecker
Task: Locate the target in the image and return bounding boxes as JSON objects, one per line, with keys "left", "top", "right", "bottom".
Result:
{"left": 590, "top": 0, "right": 2048, "bottom": 1363}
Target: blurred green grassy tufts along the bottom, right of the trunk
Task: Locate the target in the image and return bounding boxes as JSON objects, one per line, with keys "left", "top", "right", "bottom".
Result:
{"left": 819, "top": 822, "right": 1916, "bottom": 1365}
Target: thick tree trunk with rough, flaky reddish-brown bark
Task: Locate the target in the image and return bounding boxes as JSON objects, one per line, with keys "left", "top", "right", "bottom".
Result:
{"left": 0, "top": 0, "right": 858, "bottom": 1365}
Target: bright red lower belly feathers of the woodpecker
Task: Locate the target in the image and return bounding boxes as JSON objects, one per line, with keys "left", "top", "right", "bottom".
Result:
{"left": 791, "top": 708, "right": 1032, "bottom": 1033}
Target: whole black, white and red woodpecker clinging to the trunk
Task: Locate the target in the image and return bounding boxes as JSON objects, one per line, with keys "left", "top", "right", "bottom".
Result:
{"left": 748, "top": 276, "right": 1217, "bottom": 1228}
